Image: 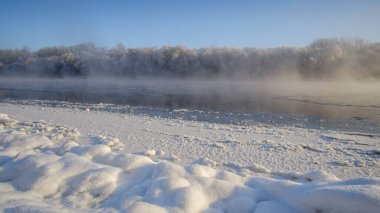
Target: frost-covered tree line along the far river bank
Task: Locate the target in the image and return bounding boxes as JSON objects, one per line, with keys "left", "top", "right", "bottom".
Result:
{"left": 0, "top": 38, "right": 380, "bottom": 79}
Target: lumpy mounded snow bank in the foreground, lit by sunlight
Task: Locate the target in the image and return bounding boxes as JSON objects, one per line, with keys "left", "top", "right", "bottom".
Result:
{"left": 0, "top": 114, "right": 380, "bottom": 213}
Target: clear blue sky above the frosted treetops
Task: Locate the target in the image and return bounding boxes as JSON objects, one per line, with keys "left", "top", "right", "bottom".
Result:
{"left": 0, "top": 0, "right": 380, "bottom": 49}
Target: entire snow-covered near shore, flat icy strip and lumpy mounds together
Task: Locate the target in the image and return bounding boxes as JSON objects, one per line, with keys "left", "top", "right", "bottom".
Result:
{"left": 0, "top": 104, "right": 380, "bottom": 212}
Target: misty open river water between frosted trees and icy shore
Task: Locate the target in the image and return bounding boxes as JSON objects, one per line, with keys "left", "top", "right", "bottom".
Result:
{"left": 0, "top": 79, "right": 380, "bottom": 123}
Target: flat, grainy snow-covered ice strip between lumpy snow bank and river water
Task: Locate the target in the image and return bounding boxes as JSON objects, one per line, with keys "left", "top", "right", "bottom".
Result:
{"left": 0, "top": 102, "right": 380, "bottom": 179}
